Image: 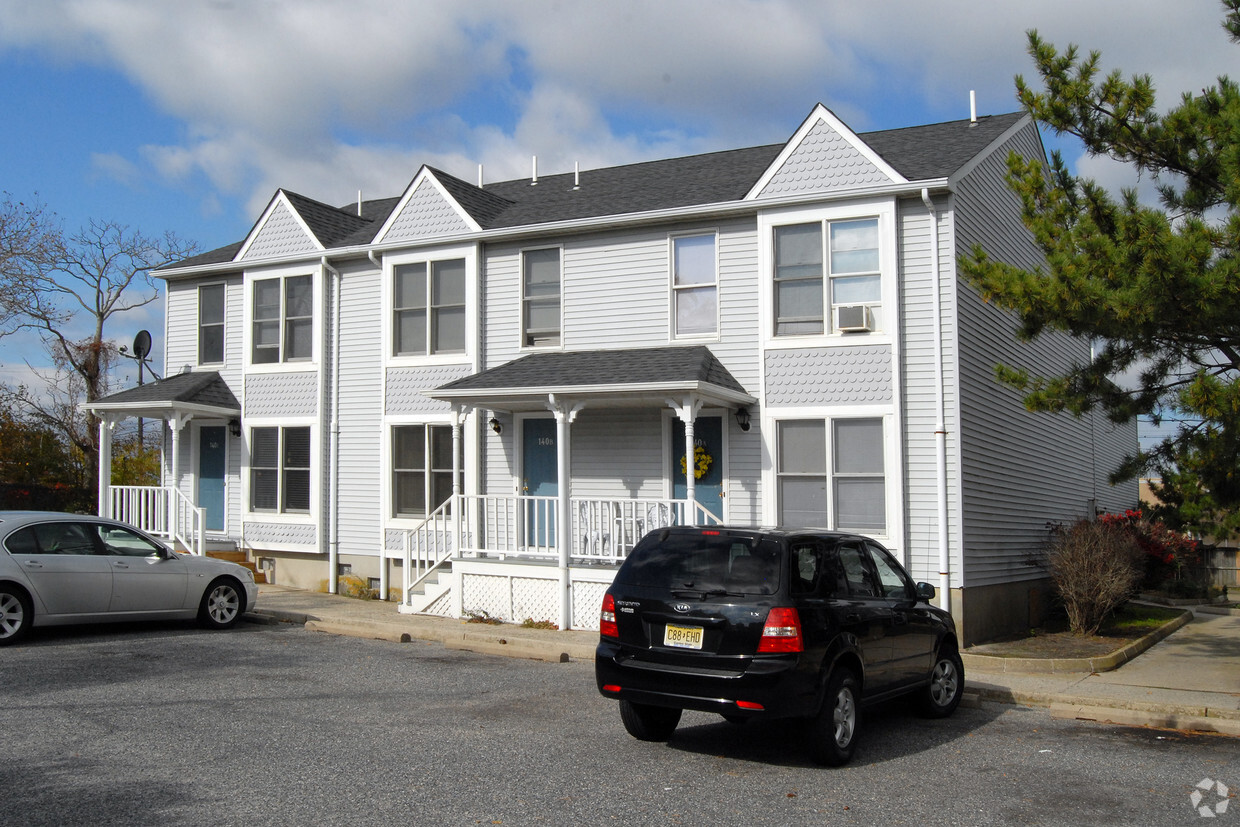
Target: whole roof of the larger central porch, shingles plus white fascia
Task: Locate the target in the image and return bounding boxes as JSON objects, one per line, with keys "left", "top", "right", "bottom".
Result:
{"left": 427, "top": 346, "right": 758, "bottom": 412}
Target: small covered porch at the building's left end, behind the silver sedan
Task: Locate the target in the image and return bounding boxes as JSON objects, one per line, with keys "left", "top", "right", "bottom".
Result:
{"left": 82, "top": 371, "right": 241, "bottom": 554}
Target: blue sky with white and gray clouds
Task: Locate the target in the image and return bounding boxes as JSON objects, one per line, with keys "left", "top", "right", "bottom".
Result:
{"left": 0, "top": 0, "right": 1240, "bottom": 448}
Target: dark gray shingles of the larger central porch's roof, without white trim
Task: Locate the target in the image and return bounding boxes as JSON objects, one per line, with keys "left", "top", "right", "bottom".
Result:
{"left": 436, "top": 345, "right": 746, "bottom": 394}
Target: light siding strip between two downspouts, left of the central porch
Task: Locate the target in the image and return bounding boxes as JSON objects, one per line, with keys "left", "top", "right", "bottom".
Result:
{"left": 334, "top": 269, "right": 386, "bottom": 554}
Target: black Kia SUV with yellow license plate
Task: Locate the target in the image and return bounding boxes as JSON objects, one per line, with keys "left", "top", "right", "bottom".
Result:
{"left": 594, "top": 526, "right": 965, "bottom": 765}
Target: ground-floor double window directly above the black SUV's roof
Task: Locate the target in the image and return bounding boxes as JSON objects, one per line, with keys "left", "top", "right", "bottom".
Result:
{"left": 775, "top": 419, "right": 887, "bottom": 533}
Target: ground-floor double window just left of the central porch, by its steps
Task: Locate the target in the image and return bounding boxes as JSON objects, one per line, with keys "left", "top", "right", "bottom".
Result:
{"left": 392, "top": 425, "right": 453, "bottom": 517}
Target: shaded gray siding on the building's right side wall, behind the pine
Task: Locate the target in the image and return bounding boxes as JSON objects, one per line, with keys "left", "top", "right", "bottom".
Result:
{"left": 955, "top": 125, "right": 1136, "bottom": 585}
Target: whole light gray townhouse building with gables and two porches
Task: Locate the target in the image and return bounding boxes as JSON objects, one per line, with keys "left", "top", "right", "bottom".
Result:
{"left": 82, "top": 105, "right": 1137, "bottom": 643}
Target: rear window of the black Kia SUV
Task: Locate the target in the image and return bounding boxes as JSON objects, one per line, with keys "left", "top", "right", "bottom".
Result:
{"left": 616, "top": 532, "right": 781, "bottom": 594}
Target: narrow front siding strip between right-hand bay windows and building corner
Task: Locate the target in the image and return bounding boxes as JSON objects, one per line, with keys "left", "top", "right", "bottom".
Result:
{"left": 897, "top": 198, "right": 961, "bottom": 585}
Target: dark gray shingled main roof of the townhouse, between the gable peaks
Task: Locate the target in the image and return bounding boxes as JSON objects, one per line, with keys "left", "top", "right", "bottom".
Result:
{"left": 157, "top": 112, "right": 1024, "bottom": 268}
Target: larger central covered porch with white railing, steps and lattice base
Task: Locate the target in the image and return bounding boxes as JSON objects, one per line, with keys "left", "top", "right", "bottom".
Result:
{"left": 399, "top": 346, "right": 756, "bottom": 629}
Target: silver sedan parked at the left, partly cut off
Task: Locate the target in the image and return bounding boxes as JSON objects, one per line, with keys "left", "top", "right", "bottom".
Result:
{"left": 0, "top": 511, "right": 258, "bottom": 646}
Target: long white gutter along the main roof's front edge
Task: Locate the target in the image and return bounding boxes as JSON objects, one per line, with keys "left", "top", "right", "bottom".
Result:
{"left": 151, "top": 177, "right": 952, "bottom": 279}
